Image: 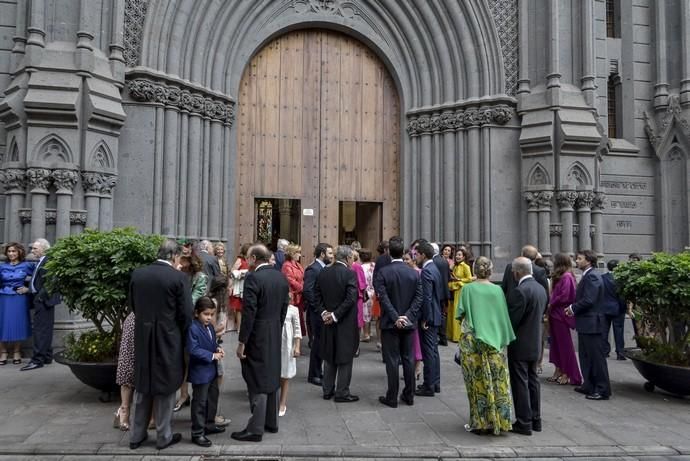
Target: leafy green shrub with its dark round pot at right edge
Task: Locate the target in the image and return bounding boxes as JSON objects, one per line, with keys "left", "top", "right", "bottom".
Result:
{"left": 614, "top": 251, "right": 690, "bottom": 395}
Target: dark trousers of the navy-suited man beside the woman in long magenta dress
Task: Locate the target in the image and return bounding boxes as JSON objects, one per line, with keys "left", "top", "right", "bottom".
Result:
{"left": 577, "top": 333, "right": 611, "bottom": 397}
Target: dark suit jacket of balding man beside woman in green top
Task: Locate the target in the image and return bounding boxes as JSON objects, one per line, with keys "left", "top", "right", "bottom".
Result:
{"left": 508, "top": 277, "right": 548, "bottom": 362}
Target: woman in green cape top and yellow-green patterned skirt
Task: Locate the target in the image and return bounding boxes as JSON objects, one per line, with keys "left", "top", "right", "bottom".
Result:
{"left": 456, "top": 256, "right": 515, "bottom": 435}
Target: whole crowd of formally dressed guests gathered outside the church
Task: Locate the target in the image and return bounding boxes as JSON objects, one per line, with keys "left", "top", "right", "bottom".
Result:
{"left": 0, "top": 237, "right": 627, "bottom": 449}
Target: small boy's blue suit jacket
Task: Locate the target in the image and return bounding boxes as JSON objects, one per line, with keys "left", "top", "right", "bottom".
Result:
{"left": 187, "top": 320, "right": 218, "bottom": 384}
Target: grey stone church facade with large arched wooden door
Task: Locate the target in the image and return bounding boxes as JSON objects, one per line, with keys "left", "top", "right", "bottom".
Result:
{"left": 0, "top": 0, "right": 690, "bottom": 264}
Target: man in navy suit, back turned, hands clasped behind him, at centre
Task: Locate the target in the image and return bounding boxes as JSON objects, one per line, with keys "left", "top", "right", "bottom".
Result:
{"left": 374, "top": 237, "right": 422, "bottom": 408}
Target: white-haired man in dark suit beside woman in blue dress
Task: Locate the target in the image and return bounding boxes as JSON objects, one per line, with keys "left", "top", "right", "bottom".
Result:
{"left": 20, "top": 239, "right": 60, "bottom": 371}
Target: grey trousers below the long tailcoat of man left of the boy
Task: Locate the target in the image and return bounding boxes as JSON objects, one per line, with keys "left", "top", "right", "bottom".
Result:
{"left": 129, "top": 391, "right": 175, "bottom": 447}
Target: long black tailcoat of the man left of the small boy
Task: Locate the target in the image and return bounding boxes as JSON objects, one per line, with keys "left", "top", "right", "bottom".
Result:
{"left": 129, "top": 261, "right": 192, "bottom": 395}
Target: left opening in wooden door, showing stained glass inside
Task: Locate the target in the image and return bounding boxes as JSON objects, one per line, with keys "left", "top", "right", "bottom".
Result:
{"left": 254, "top": 198, "right": 300, "bottom": 251}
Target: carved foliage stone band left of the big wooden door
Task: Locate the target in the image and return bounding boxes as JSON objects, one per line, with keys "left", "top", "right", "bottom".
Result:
{"left": 127, "top": 78, "right": 235, "bottom": 126}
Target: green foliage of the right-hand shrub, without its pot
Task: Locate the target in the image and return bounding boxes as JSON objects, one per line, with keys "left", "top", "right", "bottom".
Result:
{"left": 614, "top": 251, "right": 690, "bottom": 366}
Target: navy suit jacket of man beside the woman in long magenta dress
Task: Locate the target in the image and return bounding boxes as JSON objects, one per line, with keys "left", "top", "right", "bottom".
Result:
{"left": 573, "top": 269, "right": 604, "bottom": 334}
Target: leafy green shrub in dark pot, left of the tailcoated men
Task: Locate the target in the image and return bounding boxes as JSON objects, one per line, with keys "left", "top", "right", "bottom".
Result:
{"left": 46, "top": 228, "right": 163, "bottom": 393}
